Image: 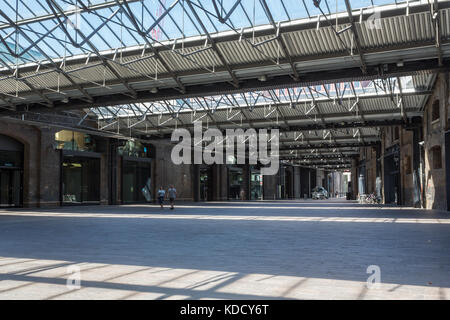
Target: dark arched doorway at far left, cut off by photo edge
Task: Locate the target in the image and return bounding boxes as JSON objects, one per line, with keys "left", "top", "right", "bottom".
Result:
{"left": 0, "top": 134, "right": 24, "bottom": 207}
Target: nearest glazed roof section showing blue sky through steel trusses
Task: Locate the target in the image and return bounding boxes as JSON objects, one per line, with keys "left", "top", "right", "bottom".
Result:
{"left": 0, "top": 0, "right": 406, "bottom": 66}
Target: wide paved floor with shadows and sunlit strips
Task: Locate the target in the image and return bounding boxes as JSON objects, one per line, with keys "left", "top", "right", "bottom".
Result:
{"left": 0, "top": 200, "right": 450, "bottom": 299}
